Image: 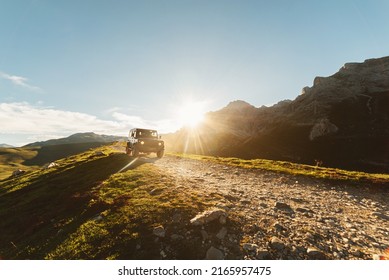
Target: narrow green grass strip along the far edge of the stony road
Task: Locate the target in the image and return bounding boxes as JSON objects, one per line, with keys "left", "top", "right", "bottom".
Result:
{"left": 170, "top": 153, "right": 389, "bottom": 185}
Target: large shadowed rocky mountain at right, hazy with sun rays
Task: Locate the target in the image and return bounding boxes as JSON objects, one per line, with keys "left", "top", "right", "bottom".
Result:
{"left": 165, "top": 57, "right": 389, "bottom": 172}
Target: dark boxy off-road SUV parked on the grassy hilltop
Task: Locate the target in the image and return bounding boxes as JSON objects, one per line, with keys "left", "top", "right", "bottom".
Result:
{"left": 126, "top": 128, "right": 165, "bottom": 158}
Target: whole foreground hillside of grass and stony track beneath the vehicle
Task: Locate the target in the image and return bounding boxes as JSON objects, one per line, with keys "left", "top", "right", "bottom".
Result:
{"left": 0, "top": 144, "right": 389, "bottom": 259}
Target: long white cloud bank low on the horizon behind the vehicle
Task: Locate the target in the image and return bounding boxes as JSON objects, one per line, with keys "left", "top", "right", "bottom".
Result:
{"left": 0, "top": 102, "right": 177, "bottom": 144}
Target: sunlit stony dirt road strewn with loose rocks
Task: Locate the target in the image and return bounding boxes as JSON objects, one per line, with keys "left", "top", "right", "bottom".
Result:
{"left": 149, "top": 156, "right": 389, "bottom": 259}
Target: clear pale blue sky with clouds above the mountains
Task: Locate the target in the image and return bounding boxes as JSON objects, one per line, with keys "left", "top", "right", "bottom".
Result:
{"left": 0, "top": 0, "right": 389, "bottom": 145}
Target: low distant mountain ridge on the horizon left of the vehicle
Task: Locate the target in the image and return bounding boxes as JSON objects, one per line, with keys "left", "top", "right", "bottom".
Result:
{"left": 24, "top": 132, "right": 125, "bottom": 147}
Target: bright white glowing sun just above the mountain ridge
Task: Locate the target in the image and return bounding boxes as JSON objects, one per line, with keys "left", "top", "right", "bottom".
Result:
{"left": 177, "top": 101, "right": 205, "bottom": 127}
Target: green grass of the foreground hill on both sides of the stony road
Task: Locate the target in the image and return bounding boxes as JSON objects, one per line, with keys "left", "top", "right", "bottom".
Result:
{"left": 0, "top": 146, "right": 388, "bottom": 259}
